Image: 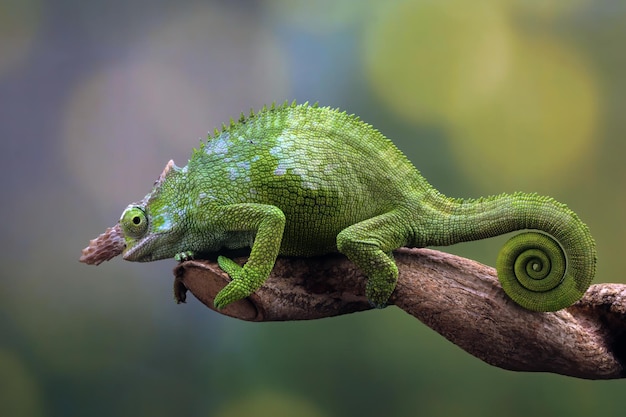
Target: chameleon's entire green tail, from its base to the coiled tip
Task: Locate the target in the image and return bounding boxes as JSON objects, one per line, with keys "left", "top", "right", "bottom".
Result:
{"left": 420, "top": 193, "right": 596, "bottom": 311}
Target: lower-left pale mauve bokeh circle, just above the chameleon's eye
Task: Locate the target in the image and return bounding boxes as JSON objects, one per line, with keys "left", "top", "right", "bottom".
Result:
{"left": 63, "top": 64, "right": 182, "bottom": 213}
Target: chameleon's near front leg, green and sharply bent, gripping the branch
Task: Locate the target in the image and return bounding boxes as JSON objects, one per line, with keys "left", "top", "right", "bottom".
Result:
{"left": 214, "top": 203, "right": 285, "bottom": 309}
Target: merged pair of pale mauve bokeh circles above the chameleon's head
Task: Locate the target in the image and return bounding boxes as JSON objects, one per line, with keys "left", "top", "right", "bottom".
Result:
{"left": 64, "top": 5, "right": 288, "bottom": 210}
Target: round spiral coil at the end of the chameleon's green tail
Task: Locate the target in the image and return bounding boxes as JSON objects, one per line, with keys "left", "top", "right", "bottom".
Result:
{"left": 496, "top": 194, "right": 596, "bottom": 311}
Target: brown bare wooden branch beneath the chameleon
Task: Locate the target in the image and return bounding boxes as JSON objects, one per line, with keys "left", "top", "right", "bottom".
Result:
{"left": 174, "top": 248, "right": 626, "bottom": 379}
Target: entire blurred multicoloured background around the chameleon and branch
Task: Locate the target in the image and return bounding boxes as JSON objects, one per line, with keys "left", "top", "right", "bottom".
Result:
{"left": 0, "top": 0, "right": 626, "bottom": 417}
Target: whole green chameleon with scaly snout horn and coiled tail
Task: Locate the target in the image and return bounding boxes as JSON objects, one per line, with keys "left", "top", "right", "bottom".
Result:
{"left": 80, "top": 101, "right": 596, "bottom": 311}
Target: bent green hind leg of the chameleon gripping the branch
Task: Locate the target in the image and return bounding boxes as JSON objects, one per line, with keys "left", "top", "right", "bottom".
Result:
{"left": 337, "top": 212, "right": 407, "bottom": 308}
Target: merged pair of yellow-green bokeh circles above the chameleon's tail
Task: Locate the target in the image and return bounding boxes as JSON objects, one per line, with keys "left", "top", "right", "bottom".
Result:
{"left": 364, "top": 0, "right": 599, "bottom": 187}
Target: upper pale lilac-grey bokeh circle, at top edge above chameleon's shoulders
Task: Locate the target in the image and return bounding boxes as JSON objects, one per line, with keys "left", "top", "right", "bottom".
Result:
{"left": 133, "top": 3, "right": 290, "bottom": 114}
